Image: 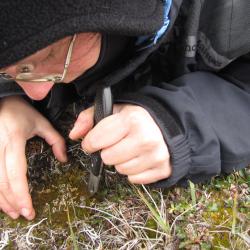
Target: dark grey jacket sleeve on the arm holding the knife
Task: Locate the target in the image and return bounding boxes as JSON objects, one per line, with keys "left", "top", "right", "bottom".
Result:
{"left": 116, "top": 72, "right": 250, "bottom": 187}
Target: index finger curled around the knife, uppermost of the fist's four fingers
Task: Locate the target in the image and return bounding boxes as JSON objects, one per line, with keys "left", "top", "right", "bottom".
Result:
{"left": 82, "top": 114, "right": 128, "bottom": 153}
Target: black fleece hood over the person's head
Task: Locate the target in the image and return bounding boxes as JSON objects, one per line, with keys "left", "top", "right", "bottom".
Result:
{"left": 0, "top": 0, "right": 164, "bottom": 68}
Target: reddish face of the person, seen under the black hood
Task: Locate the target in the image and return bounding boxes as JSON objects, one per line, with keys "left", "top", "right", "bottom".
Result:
{"left": 1, "top": 33, "right": 101, "bottom": 100}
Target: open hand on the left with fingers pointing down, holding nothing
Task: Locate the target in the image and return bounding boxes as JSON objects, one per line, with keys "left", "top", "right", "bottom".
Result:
{"left": 0, "top": 96, "right": 67, "bottom": 220}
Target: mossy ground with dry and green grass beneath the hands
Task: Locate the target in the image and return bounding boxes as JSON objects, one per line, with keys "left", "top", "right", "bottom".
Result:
{"left": 0, "top": 104, "right": 250, "bottom": 250}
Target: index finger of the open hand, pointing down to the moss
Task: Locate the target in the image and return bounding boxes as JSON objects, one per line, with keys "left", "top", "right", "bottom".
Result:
{"left": 6, "top": 137, "right": 35, "bottom": 220}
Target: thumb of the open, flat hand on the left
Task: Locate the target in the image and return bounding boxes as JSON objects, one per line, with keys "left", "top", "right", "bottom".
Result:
{"left": 35, "top": 119, "right": 67, "bottom": 162}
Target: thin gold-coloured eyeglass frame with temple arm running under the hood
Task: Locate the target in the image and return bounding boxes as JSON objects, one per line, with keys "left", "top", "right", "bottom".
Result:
{"left": 0, "top": 34, "right": 77, "bottom": 83}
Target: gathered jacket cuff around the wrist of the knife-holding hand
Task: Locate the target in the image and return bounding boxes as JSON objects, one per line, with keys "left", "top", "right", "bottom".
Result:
{"left": 115, "top": 93, "right": 191, "bottom": 188}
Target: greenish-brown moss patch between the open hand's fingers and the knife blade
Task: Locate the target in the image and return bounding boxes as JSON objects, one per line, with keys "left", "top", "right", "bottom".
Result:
{"left": 32, "top": 168, "right": 90, "bottom": 228}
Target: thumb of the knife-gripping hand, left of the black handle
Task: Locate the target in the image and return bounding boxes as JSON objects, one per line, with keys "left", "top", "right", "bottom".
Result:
{"left": 69, "top": 107, "right": 94, "bottom": 140}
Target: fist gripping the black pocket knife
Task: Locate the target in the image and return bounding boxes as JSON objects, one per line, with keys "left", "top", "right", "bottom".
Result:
{"left": 69, "top": 104, "right": 171, "bottom": 184}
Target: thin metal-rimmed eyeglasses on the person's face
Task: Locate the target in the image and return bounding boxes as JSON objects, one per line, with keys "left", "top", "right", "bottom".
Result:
{"left": 0, "top": 34, "right": 76, "bottom": 83}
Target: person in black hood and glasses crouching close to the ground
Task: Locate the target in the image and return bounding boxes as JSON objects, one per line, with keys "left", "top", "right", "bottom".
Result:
{"left": 0, "top": 0, "right": 250, "bottom": 220}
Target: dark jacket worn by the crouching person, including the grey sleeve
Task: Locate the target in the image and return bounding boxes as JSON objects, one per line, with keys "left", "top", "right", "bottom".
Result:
{"left": 2, "top": 0, "right": 250, "bottom": 187}
